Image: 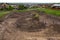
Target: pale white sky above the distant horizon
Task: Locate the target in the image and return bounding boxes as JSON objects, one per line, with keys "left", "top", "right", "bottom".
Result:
{"left": 0, "top": 0, "right": 60, "bottom": 3}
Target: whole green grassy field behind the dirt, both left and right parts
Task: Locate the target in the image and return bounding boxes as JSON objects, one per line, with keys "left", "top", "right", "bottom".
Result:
{"left": 0, "top": 8, "right": 60, "bottom": 17}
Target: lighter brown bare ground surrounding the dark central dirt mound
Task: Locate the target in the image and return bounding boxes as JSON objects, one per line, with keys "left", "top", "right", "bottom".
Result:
{"left": 0, "top": 11, "right": 60, "bottom": 40}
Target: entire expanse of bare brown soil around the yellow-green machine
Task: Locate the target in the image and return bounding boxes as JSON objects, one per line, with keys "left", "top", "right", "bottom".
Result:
{"left": 0, "top": 11, "right": 60, "bottom": 40}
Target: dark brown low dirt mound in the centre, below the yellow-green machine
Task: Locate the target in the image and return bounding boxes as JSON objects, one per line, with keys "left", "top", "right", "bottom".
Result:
{"left": 16, "top": 18, "right": 46, "bottom": 31}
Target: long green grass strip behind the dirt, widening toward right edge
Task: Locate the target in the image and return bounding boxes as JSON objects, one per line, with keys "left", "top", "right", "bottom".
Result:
{"left": 17, "top": 8, "right": 60, "bottom": 16}
